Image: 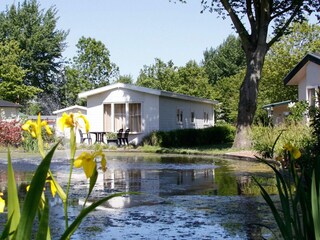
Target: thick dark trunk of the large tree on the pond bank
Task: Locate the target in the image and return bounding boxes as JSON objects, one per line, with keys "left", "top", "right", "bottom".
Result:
{"left": 233, "top": 46, "right": 267, "bottom": 149}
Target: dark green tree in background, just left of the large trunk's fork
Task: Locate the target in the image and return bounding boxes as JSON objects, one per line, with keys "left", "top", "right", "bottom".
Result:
{"left": 202, "top": 35, "right": 246, "bottom": 84}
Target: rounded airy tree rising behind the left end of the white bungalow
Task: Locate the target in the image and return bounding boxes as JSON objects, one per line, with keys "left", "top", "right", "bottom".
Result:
{"left": 72, "top": 37, "right": 119, "bottom": 90}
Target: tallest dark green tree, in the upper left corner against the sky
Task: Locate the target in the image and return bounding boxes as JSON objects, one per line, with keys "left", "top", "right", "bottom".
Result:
{"left": 0, "top": 0, "right": 67, "bottom": 92}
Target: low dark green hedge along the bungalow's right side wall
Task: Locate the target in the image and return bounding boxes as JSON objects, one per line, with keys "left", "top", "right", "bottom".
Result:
{"left": 142, "top": 125, "right": 235, "bottom": 148}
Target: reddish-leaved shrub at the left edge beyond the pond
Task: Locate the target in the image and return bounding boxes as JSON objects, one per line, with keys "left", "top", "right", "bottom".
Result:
{"left": 0, "top": 120, "right": 22, "bottom": 147}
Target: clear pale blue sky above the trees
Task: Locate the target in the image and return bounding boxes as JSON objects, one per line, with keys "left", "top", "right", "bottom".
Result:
{"left": 0, "top": 0, "right": 234, "bottom": 80}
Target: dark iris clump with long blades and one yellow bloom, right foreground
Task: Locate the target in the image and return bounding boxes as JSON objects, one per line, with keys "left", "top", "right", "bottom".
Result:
{"left": 254, "top": 144, "right": 320, "bottom": 240}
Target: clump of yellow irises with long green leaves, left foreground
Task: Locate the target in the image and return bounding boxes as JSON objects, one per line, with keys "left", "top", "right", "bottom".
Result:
{"left": 0, "top": 113, "right": 123, "bottom": 239}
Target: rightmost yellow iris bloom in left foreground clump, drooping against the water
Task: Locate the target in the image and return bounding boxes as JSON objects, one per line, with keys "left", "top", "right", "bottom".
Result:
{"left": 74, "top": 150, "right": 107, "bottom": 178}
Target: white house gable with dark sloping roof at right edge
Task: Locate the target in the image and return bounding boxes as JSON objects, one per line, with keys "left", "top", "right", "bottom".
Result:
{"left": 283, "top": 53, "right": 320, "bottom": 106}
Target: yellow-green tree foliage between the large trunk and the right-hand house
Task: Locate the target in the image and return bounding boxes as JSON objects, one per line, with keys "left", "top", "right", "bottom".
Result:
{"left": 258, "top": 22, "right": 320, "bottom": 106}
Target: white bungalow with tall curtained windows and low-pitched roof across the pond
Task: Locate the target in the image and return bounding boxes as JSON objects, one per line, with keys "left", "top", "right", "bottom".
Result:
{"left": 79, "top": 83, "right": 217, "bottom": 144}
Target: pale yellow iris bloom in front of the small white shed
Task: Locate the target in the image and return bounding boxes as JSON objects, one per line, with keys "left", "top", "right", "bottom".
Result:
{"left": 58, "top": 113, "right": 90, "bottom": 133}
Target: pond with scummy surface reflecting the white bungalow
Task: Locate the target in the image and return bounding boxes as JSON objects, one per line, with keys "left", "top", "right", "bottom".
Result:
{"left": 0, "top": 151, "right": 276, "bottom": 239}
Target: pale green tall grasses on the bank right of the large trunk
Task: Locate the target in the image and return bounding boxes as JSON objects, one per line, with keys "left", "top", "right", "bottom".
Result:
{"left": 252, "top": 123, "right": 313, "bottom": 157}
